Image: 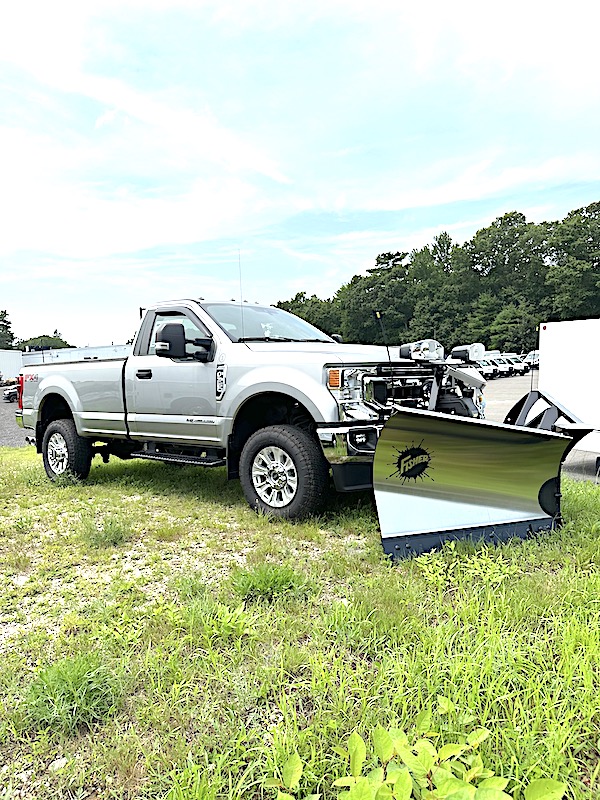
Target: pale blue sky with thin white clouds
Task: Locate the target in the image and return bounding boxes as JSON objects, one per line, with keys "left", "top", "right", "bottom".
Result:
{"left": 0, "top": 0, "right": 600, "bottom": 346}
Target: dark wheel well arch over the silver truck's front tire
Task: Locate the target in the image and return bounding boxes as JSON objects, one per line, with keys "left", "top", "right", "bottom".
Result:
{"left": 227, "top": 392, "right": 316, "bottom": 478}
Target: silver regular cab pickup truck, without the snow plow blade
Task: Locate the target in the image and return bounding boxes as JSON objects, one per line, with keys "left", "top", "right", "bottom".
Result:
{"left": 17, "top": 300, "right": 485, "bottom": 519}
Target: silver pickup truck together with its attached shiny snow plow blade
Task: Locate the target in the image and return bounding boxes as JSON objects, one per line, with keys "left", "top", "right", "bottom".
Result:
{"left": 17, "top": 300, "right": 584, "bottom": 552}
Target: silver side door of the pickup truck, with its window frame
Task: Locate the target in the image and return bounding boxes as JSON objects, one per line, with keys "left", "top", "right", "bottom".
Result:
{"left": 125, "top": 308, "right": 221, "bottom": 446}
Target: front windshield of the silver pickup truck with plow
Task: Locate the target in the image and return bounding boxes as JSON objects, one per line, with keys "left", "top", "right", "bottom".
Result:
{"left": 201, "top": 303, "right": 334, "bottom": 342}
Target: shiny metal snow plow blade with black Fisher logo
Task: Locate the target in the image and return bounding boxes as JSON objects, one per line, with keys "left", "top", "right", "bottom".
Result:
{"left": 373, "top": 409, "right": 573, "bottom": 557}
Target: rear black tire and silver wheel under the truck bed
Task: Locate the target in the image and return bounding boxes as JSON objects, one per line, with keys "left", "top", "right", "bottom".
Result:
{"left": 42, "top": 419, "right": 93, "bottom": 481}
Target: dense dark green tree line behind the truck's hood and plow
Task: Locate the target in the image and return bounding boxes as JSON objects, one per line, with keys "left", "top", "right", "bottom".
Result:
{"left": 277, "top": 202, "right": 600, "bottom": 352}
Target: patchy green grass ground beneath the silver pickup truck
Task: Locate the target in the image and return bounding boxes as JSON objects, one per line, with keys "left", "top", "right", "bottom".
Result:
{"left": 0, "top": 449, "right": 600, "bottom": 800}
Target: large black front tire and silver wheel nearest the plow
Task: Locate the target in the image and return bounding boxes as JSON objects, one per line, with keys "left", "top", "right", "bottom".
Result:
{"left": 240, "top": 425, "right": 329, "bottom": 519}
